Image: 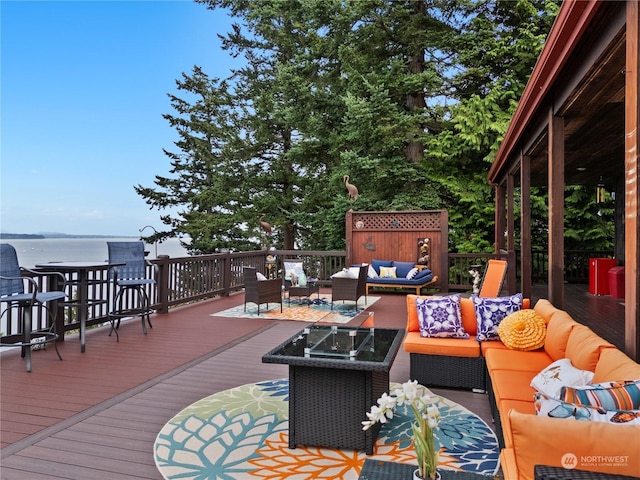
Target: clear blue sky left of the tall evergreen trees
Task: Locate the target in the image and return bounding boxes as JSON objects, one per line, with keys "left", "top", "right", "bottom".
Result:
{"left": 0, "top": 0, "right": 238, "bottom": 236}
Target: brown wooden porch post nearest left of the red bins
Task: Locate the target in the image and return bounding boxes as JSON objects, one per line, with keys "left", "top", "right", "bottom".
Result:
{"left": 548, "top": 112, "right": 564, "bottom": 309}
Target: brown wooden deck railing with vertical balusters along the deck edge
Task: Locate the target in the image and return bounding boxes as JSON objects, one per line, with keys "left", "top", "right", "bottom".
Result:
{"left": 0, "top": 250, "right": 610, "bottom": 343}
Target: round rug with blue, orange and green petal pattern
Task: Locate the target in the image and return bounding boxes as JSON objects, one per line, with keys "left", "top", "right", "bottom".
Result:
{"left": 154, "top": 379, "right": 499, "bottom": 480}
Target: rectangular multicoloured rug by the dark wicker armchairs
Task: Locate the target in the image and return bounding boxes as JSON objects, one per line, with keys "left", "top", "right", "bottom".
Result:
{"left": 211, "top": 294, "right": 380, "bottom": 323}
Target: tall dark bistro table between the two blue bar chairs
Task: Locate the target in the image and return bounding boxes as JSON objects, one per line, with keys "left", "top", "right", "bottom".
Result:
{"left": 36, "top": 261, "right": 124, "bottom": 353}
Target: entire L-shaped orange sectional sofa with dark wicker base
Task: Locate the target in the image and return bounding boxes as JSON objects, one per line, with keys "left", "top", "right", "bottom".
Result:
{"left": 404, "top": 295, "right": 640, "bottom": 480}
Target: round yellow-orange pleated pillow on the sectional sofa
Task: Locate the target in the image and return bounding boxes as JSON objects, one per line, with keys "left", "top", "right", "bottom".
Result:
{"left": 498, "top": 308, "right": 547, "bottom": 352}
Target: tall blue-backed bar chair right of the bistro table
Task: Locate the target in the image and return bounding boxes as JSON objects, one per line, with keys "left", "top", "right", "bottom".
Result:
{"left": 107, "top": 242, "right": 156, "bottom": 341}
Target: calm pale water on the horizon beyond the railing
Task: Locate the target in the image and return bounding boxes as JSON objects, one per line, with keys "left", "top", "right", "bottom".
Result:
{"left": 0, "top": 237, "right": 189, "bottom": 268}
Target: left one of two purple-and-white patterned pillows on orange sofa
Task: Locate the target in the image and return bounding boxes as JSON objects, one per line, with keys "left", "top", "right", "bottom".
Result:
{"left": 416, "top": 295, "right": 469, "bottom": 338}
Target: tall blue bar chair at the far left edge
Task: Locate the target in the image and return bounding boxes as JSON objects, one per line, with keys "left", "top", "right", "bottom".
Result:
{"left": 0, "top": 243, "right": 67, "bottom": 372}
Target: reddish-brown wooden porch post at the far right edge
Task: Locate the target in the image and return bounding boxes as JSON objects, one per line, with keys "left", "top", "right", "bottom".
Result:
{"left": 624, "top": 0, "right": 640, "bottom": 360}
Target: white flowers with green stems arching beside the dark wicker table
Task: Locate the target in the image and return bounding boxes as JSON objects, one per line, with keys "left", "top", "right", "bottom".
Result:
{"left": 362, "top": 380, "right": 440, "bottom": 479}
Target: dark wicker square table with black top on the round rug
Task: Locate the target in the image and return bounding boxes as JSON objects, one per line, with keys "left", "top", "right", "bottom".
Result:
{"left": 262, "top": 325, "right": 404, "bottom": 455}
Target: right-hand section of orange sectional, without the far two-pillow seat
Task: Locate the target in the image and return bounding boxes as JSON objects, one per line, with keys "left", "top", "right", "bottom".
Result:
{"left": 482, "top": 300, "right": 640, "bottom": 480}
